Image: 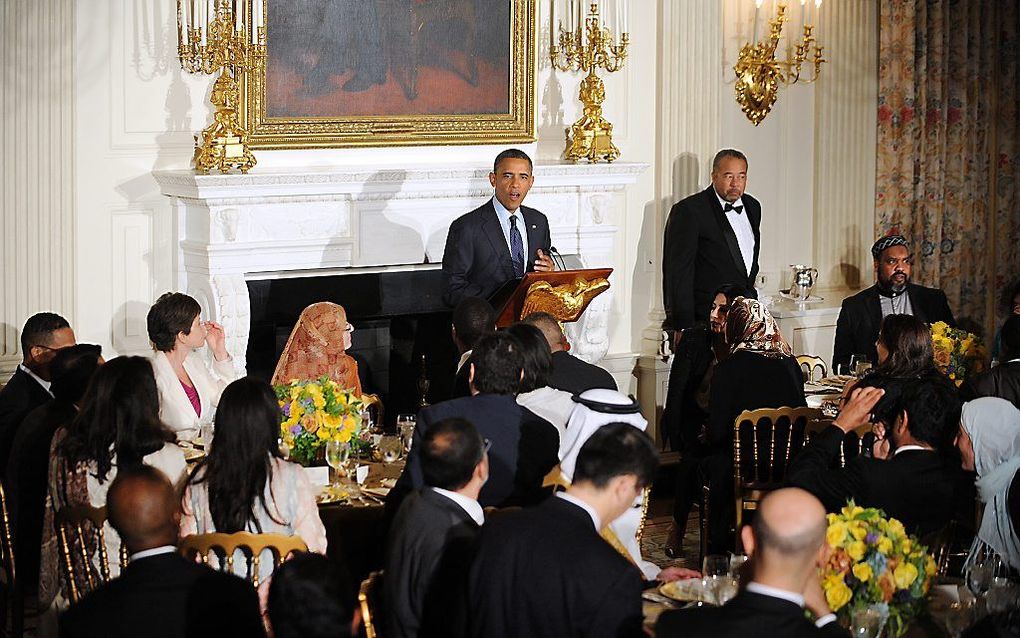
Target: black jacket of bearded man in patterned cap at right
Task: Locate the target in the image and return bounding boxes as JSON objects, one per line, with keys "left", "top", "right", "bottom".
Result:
{"left": 832, "top": 284, "right": 956, "bottom": 370}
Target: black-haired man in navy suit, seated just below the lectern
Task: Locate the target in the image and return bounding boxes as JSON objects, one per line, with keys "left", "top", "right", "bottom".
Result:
{"left": 387, "top": 333, "right": 559, "bottom": 512}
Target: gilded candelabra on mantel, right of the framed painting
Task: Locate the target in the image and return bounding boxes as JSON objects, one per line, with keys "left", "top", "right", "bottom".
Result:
{"left": 549, "top": 2, "right": 630, "bottom": 162}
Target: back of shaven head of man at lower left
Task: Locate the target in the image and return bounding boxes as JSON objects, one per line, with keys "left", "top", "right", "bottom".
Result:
{"left": 106, "top": 465, "right": 181, "bottom": 553}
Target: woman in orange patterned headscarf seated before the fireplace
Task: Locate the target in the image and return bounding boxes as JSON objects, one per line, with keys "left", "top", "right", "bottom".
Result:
{"left": 272, "top": 301, "right": 361, "bottom": 396}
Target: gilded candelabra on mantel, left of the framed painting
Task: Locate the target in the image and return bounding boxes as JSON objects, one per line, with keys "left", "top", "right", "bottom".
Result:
{"left": 177, "top": 0, "right": 265, "bottom": 174}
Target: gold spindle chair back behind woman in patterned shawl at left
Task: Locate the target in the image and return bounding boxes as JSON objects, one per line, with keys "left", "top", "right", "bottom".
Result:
{"left": 53, "top": 505, "right": 128, "bottom": 602}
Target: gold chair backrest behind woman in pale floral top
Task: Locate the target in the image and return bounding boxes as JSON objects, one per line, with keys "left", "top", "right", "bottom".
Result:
{"left": 177, "top": 532, "right": 308, "bottom": 589}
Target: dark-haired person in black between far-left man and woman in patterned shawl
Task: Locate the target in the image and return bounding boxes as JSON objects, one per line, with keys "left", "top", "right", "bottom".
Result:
{"left": 4, "top": 343, "right": 103, "bottom": 595}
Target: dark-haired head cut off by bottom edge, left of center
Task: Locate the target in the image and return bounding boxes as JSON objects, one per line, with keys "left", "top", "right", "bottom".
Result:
{"left": 269, "top": 552, "right": 357, "bottom": 638}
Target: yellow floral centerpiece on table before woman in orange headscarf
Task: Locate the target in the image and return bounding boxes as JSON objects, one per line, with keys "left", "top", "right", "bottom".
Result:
{"left": 274, "top": 377, "right": 364, "bottom": 465}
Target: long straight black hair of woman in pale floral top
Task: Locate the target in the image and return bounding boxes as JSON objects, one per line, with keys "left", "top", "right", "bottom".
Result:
{"left": 191, "top": 377, "right": 285, "bottom": 534}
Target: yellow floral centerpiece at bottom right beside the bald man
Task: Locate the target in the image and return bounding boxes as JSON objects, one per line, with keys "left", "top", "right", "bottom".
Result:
{"left": 821, "top": 500, "right": 935, "bottom": 637}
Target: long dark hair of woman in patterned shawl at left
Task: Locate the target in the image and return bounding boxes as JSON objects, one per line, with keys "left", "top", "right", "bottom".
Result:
{"left": 58, "top": 356, "right": 173, "bottom": 482}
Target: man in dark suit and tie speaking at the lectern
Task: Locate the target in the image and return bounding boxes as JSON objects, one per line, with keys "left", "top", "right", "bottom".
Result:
{"left": 443, "top": 148, "right": 556, "bottom": 306}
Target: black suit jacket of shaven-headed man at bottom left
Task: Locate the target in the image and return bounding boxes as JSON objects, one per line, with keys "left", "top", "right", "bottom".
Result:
{"left": 60, "top": 552, "right": 265, "bottom": 638}
